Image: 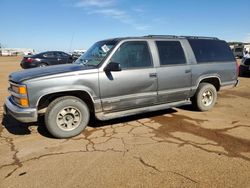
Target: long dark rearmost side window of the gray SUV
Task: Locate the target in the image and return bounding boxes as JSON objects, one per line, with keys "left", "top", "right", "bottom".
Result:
{"left": 188, "top": 39, "right": 234, "bottom": 63}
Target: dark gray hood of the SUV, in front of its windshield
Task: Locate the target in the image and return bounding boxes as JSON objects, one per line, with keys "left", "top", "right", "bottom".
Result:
{"left": 9, "top": 64, "right": 93, "bottom": 83}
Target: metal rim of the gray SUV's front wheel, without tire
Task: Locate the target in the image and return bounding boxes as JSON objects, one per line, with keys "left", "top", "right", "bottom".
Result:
{"left": 56, "top": 106, "right": 82, "bottom": 131}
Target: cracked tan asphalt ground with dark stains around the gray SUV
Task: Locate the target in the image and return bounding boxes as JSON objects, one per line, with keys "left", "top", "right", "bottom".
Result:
{"left": 0, "top": 57, "right": 250, "bottom": 188}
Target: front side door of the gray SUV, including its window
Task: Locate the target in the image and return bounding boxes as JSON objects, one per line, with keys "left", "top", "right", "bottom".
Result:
{"left": 99, "top": 41, "right": 157, "bottom": 112}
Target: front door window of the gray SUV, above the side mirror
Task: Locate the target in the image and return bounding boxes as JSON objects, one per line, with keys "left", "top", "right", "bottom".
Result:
{"left": 111, "top": 41, "right": 152, "bottom": 69}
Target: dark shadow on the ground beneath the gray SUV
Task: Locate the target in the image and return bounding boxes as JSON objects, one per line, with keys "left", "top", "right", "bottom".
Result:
{"left": 2, "top": 108, "right": 177, "bottom": 138}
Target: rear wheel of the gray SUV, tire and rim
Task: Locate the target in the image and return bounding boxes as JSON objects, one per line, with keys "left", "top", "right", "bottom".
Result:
{"left": 192, "top": 83, "right": 217, "bottom": 111}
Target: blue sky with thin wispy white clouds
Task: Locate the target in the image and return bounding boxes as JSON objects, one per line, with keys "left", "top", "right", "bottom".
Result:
{"left": 0, "top": 0, "right": 250, "bottom": 52}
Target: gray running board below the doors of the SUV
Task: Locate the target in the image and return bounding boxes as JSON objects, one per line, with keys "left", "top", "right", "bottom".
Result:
{"left": 95, "top": 100, "right": 191, "bottom": 121}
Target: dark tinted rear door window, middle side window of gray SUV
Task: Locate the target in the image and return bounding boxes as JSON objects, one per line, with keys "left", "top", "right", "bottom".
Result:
{"left": 156, "top": 41, "right": 186, "bottom": 65}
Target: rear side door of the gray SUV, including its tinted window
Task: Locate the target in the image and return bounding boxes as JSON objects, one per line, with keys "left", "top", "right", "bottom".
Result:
{"left": 155, "top": 40, "right": 192, "bottom": 103}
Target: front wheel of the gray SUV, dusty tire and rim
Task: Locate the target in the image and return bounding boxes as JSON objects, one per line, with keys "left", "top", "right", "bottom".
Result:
{"left": 45, "top": 96, "right": 90, "bottom": 138}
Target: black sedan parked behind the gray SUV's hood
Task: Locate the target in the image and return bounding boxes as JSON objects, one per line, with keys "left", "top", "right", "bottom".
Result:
{"left": 20, "top": 51, "right": 73, "bottom": 69}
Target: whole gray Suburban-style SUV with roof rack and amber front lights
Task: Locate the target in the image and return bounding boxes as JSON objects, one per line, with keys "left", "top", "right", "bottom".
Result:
{"left": 5, "top": 35, "right": 238, "bottom": 138}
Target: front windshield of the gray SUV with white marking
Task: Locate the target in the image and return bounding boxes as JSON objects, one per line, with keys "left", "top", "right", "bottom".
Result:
{"left": 74, "top": 40, "right": 117, "bottom": 67}
